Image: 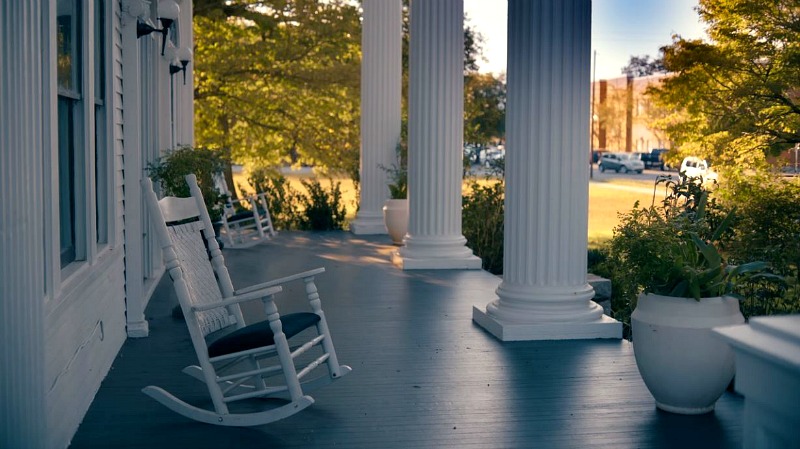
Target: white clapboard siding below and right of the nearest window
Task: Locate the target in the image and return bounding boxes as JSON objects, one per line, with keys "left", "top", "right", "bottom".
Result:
{"left": 41, "top": 0, "right": 125, "bottom": 448}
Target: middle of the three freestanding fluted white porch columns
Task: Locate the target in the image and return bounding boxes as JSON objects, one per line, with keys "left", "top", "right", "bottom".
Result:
{"left": 394, "top": 0, "right": 481, "bottom": 269}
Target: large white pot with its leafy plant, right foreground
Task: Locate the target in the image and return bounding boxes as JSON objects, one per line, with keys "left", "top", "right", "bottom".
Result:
{"left": 611, "top": 176, "right": 775, "bottom": 414}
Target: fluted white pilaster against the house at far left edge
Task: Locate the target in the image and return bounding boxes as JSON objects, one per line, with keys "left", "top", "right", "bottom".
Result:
{"left": 0, "top": 0, "right": 48, "bottom": 448}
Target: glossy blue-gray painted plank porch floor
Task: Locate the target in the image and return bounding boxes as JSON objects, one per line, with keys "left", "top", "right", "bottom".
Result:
{"left": 71, "top": 232, "right": 743, "bottom": 449}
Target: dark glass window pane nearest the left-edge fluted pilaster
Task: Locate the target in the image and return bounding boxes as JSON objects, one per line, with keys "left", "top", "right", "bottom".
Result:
{"left": 56, "top": 0, "right": 85, "bottom": 268}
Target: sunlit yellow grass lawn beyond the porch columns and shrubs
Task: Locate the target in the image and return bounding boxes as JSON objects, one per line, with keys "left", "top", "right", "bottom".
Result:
{"left": 233, "top": 168, "right": 653, "bottom": 247}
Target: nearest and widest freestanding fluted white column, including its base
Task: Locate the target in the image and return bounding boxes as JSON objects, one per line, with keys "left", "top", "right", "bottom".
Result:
{"left": 473, "top": 0, "right": 622, "bottom": 340}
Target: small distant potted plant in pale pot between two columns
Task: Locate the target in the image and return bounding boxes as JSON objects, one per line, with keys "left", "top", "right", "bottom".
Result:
{"left": 381, "top": 140, "right": 408, "bottom": 245}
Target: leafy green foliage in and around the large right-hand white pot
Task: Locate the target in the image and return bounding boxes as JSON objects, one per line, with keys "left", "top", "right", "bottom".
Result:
{"left": 591, "top": 177, "right": 788, "bottom": 338}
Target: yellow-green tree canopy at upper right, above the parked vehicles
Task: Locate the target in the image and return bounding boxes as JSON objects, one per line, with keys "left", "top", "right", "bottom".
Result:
{"left": 650, "top": 0, "right": 800, "bottom": 164}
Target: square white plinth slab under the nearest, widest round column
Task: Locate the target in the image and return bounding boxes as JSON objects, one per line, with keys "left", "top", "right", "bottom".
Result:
{"left": 472, "top": 306, "right": 622, "bottom": 341}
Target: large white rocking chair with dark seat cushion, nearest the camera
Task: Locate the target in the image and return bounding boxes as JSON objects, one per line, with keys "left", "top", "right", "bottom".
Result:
{"left": 142, "top": 175, "right": 351, "bottom": 426}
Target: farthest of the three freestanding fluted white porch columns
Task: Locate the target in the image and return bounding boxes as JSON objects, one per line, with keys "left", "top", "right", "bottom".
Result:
{"left": 350, "top": 0, "right": 403, "bottom": 234}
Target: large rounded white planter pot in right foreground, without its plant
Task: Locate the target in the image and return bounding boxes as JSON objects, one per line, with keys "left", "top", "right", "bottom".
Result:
{"left": 631, "top": 294, "right": 744, "bottom": 415}
